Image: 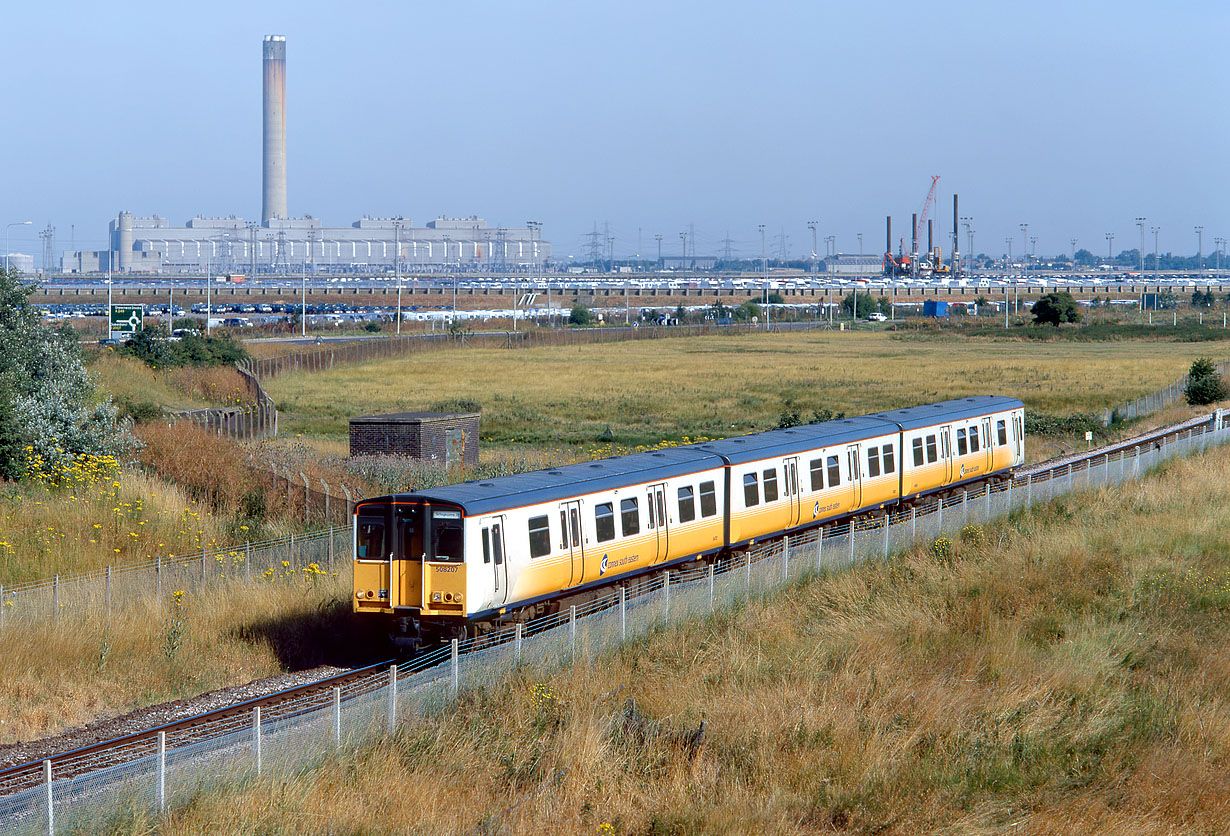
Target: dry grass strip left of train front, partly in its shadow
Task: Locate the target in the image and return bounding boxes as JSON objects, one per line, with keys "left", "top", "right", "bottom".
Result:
{"left": 0, "top": 568, "right": 364, "bottom": 744}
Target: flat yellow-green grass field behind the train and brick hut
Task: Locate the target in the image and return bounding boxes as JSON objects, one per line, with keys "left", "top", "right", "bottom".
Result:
{"left": 267, "top": 332, "right": 1220, "bottom": 448}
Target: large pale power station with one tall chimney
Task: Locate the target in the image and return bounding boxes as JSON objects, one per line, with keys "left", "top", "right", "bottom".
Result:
{"left": 60, "top": 34, "right": 551, "bottom": 275}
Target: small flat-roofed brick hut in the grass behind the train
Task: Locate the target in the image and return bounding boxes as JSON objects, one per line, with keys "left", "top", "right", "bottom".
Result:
{"left": 351, "top": 412, "right": 478, "bottom": 465}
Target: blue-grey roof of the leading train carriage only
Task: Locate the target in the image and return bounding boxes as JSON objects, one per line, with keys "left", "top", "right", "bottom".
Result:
{"left": 364, "top": 445, "right": 724, "bottom": 516}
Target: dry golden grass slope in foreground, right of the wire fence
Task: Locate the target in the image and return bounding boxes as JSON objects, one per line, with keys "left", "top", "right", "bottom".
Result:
{"left": 151, "top": 440, "right": 1230, "bottom": 836}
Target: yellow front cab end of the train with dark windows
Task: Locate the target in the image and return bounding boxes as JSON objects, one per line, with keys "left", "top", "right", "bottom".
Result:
{"left": 353, "top": 498, "right": 467, "bottom": 649}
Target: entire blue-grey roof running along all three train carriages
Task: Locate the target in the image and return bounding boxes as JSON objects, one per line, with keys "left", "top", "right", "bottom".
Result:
{"left": 363, "top": 395, "right": 1025, "bottom": 516}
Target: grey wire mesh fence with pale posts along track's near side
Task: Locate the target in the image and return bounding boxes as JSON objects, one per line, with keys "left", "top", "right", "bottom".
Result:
{"left": 0, "top": 412, "right": 1230, "bottom": 836}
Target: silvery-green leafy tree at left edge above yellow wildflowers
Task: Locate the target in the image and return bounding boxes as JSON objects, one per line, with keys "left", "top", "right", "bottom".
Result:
{"left": 0, "top": 270, "right": 133, "bottom": 478}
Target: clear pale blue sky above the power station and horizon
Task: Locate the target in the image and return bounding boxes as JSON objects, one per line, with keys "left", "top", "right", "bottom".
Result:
{"left": 0, "top": 0, "right": 1230, "bottom": 257}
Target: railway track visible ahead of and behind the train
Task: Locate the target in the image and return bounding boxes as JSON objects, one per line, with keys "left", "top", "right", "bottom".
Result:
{"left": 0, "top": 412, "right": 1230, "bottom": 797}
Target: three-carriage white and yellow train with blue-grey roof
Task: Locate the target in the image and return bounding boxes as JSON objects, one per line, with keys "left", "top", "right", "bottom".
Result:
{"left": 353, "top": 396, "right": 1025, "bottom": 650}
